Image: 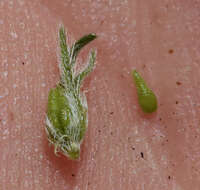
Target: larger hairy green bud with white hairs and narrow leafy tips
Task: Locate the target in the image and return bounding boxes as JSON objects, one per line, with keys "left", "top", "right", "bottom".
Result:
{"left": 46, "top": 26, "right": 96, "bottom": 160}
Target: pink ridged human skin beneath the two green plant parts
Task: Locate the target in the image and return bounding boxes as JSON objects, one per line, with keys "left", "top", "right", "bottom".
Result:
{"left": 0, "top": 0, "right": 200, "bottom": 190}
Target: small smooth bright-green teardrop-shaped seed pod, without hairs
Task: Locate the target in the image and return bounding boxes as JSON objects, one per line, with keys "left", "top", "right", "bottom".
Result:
{"left": 132, "top": 70, "right": 157, "bottom": 113}
